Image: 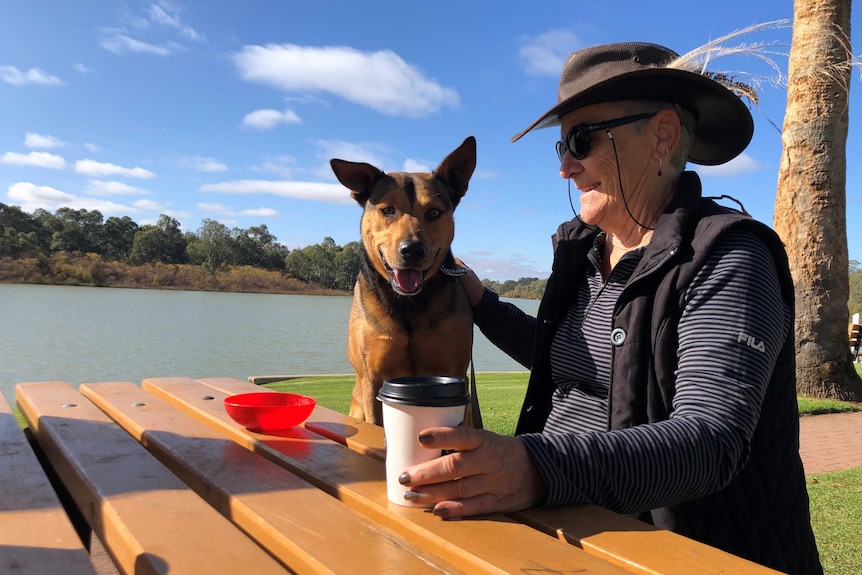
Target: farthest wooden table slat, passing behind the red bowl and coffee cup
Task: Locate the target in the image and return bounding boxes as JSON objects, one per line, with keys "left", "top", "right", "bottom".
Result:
{"left": 198, "top": 378, "right": 788, "bottom": 575}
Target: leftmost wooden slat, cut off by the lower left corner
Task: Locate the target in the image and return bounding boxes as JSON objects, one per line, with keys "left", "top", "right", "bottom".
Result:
{"left": 0, "top": 394, "right": 95, "bottom": 575}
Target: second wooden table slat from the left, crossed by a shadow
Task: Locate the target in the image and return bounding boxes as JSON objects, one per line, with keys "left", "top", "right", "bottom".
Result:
{"left": 16, "top": 382, "right": 286, "bottom": 575}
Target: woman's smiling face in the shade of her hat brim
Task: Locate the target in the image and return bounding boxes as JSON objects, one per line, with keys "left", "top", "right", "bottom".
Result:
{"left": 560, "top": 102, "right": 658, "bottom": 234}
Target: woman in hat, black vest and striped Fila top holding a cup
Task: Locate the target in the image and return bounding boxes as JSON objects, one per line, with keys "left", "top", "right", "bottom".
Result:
{"left": 401, "top": 43, "right": 822, "bottom": 573}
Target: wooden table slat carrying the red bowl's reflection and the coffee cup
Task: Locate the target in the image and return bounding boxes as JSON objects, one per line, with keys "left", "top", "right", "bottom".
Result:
{"left": 143, "top": 378, "right": 630, "bottom": 573}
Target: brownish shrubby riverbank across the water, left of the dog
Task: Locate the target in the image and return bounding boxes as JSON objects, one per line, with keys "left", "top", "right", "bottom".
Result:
{"left": 0, "top": 252, "right": 349, "bottom": 295}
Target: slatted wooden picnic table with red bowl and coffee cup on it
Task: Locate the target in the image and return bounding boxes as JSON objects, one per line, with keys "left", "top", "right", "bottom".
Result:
{"left": 0, "top": 377, "right": 775, "bottom": 575}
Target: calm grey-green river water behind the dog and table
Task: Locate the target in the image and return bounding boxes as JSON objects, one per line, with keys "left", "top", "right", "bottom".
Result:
{"left": 0, "top": 284, "right": 538, "bottom": 401}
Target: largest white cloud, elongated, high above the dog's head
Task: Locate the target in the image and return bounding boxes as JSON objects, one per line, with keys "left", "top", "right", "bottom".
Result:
{"left": 233, "top": 44, "right": 460, "bottom": 118}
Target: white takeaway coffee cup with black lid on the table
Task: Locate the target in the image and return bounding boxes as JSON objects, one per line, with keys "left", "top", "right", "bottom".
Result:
{"left": 377, "top": 376, "right": 470, "bottom": 507}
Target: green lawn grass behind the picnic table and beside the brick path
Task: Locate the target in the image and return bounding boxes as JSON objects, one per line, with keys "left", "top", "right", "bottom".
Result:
{"left": 266, "top": 374, "right": 862, "bottom": 575}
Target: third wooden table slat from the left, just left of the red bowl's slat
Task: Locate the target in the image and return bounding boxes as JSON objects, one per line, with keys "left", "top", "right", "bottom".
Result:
{"left": 81, "top": 383, "right": 463, "bottom": 575}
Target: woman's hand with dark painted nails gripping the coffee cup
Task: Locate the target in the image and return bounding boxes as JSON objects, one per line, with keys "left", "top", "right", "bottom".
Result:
{"left": 399, "top": 427, "right": 544, "bottom": 519}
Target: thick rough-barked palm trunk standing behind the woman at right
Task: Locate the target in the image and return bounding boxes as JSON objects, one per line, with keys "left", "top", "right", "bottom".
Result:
{"left": 774, "top": 0, "right": 862, "bottom": 401}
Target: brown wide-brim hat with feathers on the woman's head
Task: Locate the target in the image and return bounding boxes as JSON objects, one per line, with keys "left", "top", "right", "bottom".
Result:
{"left": 512, "top": 42, "right": 754, "bottom": 166}
